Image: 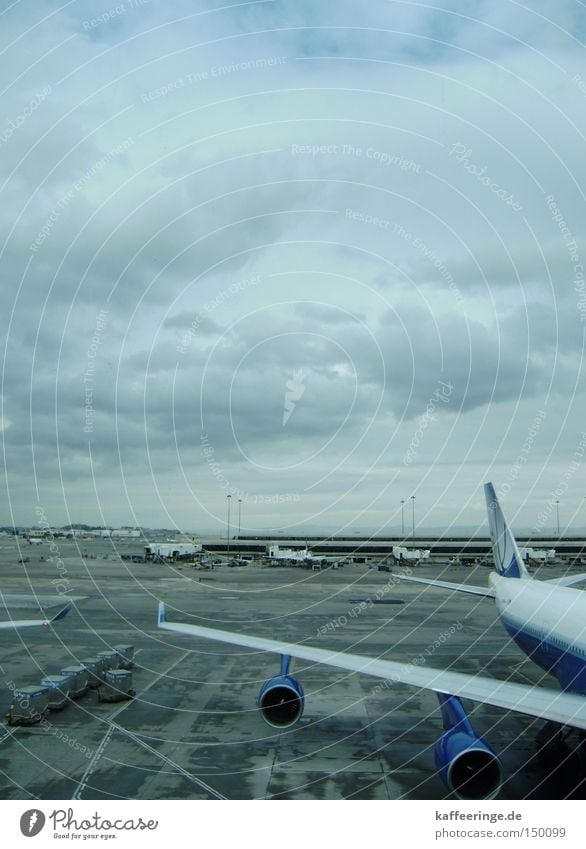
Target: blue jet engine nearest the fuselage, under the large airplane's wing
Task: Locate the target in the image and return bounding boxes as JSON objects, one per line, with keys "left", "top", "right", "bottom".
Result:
{"left": 435, "top": 693, "right": 503, "bottom": 799}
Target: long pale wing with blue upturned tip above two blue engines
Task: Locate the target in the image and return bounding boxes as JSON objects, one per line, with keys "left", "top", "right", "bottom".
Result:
{"left": 158, "top": 603, "right": 586, "bottom": 729}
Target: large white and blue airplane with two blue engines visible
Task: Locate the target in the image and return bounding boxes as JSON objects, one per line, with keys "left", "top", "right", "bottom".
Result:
{"left": 158, "top": 483, "right": 586, "bottom": 800}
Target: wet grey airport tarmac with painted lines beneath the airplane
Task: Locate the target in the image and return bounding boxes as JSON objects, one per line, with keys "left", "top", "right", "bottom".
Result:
{"left": 0, "top": 539, "right": 583, "bottom": 800}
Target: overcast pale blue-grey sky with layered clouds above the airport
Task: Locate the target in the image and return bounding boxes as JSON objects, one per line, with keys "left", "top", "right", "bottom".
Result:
{"left": 0, "top": 0, "right": 586, "bottom": 535}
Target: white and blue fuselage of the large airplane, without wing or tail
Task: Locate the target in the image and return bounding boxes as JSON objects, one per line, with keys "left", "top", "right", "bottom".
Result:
{"left": 490, "top": 573, "right": 586, "bottom": 695}
